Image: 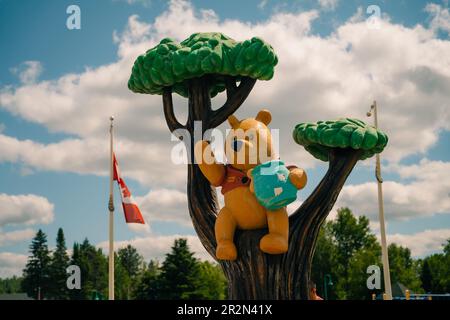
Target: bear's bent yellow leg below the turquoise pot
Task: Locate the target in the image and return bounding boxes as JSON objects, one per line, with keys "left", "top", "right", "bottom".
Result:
{"left": 259, "top": 207, "right": 289, "bottom": 254}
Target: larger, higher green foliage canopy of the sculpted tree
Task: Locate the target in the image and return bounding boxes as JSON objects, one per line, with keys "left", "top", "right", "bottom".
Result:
{"left": 128, "top": 32, "right": 278, "bottom": 97}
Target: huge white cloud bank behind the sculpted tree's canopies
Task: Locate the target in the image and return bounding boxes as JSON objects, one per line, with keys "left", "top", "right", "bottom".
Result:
{"left": 0, "top": 0, "right": 450, "bottom": 230}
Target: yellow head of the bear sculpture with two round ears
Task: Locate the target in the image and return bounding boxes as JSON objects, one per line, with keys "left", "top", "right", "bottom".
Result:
{"left": 225, "top": 110, "right": 275, "bottom": 171}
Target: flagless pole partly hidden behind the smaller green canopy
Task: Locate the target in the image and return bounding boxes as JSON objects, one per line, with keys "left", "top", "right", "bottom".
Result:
{"left": 367, "top": 101, "right": 392, "bottom": 300}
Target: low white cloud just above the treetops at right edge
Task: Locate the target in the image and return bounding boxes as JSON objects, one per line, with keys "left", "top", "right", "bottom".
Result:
{"left": 387, "top": 229, "right": 450, "bottom": 257}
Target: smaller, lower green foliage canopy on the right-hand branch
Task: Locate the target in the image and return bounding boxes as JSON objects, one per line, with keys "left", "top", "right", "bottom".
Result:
{"left": 293, "top": 118, "right": 388, "bottom": 161}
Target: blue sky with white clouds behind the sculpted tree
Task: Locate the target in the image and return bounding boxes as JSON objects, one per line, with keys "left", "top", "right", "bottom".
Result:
{"left": 0, "top": 0, "right": 450, "bottom": 277}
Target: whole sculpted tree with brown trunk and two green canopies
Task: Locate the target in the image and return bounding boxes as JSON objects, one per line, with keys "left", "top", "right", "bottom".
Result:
{"left": 128, "top": 33, "right": 387, "bottom": 299}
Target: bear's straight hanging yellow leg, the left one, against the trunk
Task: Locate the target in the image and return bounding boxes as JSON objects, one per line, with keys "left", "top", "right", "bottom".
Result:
{"left": 214, "top": 207, "right": 237, "bottom": 260}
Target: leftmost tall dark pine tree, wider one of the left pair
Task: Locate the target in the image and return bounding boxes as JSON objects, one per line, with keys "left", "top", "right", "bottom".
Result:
{"left": 22, "top": 229, "right": 51, "bottom": 300}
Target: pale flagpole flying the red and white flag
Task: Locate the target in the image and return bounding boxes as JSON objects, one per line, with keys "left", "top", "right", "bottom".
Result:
{"left": 108, "top": 116, "right": 114, "bottom": 300}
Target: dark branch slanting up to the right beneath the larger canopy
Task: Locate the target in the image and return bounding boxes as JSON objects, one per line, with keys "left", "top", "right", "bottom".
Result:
{"left": 209, "top": 77, "right": 256, "bottom": 128}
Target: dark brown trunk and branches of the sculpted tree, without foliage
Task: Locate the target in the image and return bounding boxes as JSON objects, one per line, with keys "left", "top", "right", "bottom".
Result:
{"left": 163, "top": 78, "right": 360, "bottom": 299}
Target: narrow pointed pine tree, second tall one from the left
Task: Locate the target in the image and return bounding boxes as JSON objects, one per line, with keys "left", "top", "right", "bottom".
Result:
{"left": 49, "top": 228, "right": 69, "bottom": 300}
